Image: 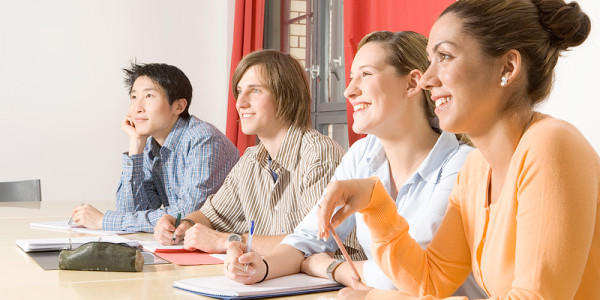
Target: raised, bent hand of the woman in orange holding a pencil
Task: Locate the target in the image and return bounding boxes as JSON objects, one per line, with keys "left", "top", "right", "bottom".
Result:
{"left": 317, "top": 177, "right": 378, "bottom": 239}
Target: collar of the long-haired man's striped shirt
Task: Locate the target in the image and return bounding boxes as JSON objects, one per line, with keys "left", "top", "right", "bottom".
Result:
{"left": 256, "top": 126, "right": 305, "bottom": 171}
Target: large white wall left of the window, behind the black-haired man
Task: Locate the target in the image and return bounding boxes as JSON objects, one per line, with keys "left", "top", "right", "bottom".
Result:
{"left": 0, "top": 0, "right": 235, "bottom": 202}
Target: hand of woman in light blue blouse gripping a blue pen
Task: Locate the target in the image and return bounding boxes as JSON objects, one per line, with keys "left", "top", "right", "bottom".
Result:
{"left": 224, "top": 242, "right": 267, "bottom": 284}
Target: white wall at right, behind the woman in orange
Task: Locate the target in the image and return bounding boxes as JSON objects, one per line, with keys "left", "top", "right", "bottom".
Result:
{"left": 538, "top": 0, "right": 600, "bottom": 153}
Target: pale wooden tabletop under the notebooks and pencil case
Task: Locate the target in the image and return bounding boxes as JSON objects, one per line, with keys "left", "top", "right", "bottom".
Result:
{"left": 0, "top": 201, "right": 337, "bottom": 300}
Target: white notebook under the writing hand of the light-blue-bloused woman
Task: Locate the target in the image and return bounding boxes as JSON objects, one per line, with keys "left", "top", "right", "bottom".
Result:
{"left": 173, "top": 273, "right": 343, "bottom": 299}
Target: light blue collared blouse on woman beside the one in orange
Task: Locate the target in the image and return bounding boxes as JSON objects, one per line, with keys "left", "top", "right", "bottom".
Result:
{"left": 283, "top": 132, "right": 473, "bottom": 289}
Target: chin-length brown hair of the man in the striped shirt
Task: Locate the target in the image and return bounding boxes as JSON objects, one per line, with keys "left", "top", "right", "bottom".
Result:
{"left": 231, "top": 50, "right": 311, "bottom": 127}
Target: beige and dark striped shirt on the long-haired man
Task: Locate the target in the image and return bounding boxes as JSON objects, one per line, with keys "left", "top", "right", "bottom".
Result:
{"left": 200, "top": 126, "right": 343, "bottom": 235}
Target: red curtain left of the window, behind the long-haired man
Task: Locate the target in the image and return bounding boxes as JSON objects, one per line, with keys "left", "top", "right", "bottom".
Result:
{"left": 226, "top": 0, "right": 265, "bottom": 154}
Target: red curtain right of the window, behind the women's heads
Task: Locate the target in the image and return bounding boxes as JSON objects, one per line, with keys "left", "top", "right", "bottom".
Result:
{"left": 344, "top": 0, "right": 454, "bottom": 145}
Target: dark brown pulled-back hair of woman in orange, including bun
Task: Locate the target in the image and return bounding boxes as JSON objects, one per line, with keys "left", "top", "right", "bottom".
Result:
{"left": 440, "top": 0, "right": 591, "bottom": 106}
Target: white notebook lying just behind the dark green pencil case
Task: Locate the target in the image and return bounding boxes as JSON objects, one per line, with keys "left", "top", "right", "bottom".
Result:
{"left": 17, "top": 235, "right": 139, "bottom": 252}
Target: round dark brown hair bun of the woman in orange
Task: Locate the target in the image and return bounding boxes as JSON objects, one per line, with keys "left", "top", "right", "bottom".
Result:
{"left": 532, "top": 0, "right": 591, "bottom": 50}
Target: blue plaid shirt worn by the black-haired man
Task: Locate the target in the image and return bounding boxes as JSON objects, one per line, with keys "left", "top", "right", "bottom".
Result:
{"left": 102, "top": 116, "right": 240, "bottom": 232}
